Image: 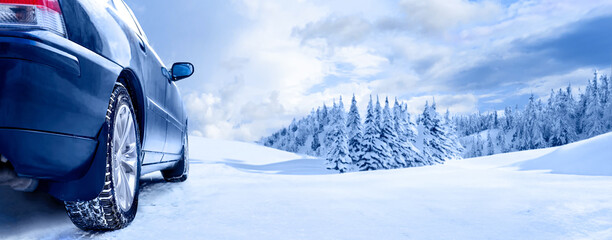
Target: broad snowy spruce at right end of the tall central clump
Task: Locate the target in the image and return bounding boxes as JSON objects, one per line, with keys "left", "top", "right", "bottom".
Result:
{"left": 419, "top": 101, "right": 463, "bottom": 164}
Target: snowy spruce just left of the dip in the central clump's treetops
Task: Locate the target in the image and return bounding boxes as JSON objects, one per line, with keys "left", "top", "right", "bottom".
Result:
{"left": 393, "top": 98, "right": 425, "bottom": 167}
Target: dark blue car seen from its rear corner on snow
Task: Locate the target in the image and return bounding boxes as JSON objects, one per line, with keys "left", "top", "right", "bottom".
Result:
{"left": 0, "top": 0, "right": 194, "bottom": 230}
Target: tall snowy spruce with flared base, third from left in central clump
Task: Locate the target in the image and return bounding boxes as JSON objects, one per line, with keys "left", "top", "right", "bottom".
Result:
{"left": 357, "top": 96, "right": 391, "bottom": 171}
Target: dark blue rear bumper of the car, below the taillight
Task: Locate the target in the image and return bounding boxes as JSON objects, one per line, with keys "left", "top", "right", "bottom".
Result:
{"left": 0, "top": 31, "right": 122, "bottom": 185}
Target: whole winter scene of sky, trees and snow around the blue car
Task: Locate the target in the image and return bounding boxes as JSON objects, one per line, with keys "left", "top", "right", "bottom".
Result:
{"left": 0, "top": 0, "right": 612, "bottom": 240}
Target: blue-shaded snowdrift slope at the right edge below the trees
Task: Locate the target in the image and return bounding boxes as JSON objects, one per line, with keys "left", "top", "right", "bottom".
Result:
{"left": 516, "top": 133, "right": 612, "bottom": 176}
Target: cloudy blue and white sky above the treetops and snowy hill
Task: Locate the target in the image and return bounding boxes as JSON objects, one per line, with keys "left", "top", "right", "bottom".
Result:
{"left": 126, "top": 0, "right": 612, "bottom": 141}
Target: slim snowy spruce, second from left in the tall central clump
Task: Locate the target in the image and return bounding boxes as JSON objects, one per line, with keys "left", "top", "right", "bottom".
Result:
{"left": 346, "top": 95, "right": 364, "bottom": 168}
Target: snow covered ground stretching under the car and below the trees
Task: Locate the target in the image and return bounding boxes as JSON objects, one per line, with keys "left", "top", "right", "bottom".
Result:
{"left": 0, "top": 134, "right": 612, "bottom": 239}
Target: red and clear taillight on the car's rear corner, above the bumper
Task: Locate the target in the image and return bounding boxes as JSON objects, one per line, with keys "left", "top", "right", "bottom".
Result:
{"left": 0, "top": 0, "right": 66, "bottom": 36}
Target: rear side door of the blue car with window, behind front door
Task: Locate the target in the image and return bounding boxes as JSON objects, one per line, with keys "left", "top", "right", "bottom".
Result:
{"left": 113, "top": 0, "right": 168, "bottom": 164}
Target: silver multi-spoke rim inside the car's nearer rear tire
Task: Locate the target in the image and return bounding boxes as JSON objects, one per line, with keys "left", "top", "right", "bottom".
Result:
{"left": 111, "top": 105, "right": 138, "bottom": 212}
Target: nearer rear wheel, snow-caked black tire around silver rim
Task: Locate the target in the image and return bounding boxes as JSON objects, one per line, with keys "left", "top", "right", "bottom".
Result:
{"left": 65, "top": 84, "right": 142, "bottom": 231}
